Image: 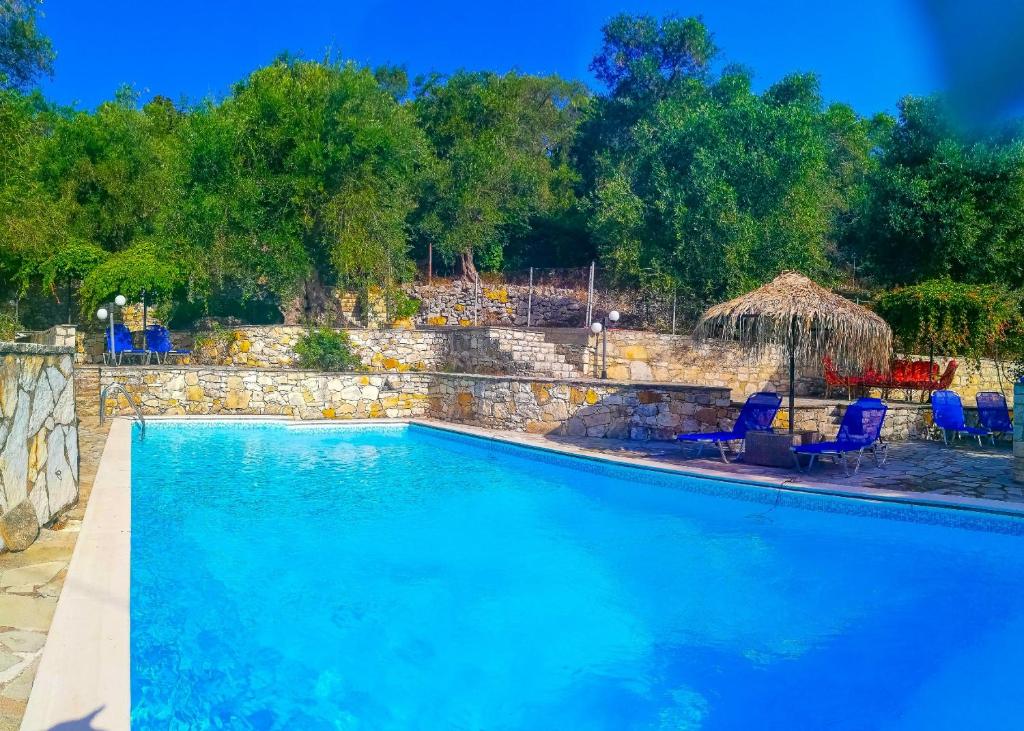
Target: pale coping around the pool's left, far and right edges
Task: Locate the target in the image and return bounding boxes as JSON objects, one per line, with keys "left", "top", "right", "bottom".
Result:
{"left": 22, "top": 417, "right": 1024, "bottom": 731}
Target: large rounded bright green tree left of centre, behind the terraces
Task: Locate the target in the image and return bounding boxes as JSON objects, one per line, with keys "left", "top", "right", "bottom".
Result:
{"left": 173, "top": 58, "right": 427, "bottom": 319}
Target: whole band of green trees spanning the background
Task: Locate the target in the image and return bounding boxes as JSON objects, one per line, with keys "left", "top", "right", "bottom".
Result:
{"left": 0, "top": 9, "right": 1024, "bottom": 341}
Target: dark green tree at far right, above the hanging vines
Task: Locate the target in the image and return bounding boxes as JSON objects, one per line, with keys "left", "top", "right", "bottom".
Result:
{"left": 851, "top": 97, "right": 1024, "bottom": 288}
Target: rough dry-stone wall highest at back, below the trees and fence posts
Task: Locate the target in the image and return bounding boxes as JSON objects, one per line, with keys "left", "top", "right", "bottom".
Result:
{"left": 404, "top": 280, "right": 587, "bottom": 328}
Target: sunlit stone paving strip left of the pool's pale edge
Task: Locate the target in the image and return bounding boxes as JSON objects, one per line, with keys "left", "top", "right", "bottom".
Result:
{"left": 0, "top": 417, "right": 110, "bottom": 731}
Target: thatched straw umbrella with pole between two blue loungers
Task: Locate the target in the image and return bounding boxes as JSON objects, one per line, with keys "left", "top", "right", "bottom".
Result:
{"left": 693, "top": 271, "right": 893, "bottom": 432}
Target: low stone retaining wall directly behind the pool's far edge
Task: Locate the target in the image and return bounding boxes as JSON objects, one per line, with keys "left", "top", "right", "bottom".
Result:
{"left": 96, "top": 367, "right": 732, "bottom": 439}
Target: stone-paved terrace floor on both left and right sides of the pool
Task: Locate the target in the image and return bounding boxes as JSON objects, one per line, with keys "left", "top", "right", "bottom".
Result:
{"left": 0, "top": 417, "right": 1024, "bottom": 731}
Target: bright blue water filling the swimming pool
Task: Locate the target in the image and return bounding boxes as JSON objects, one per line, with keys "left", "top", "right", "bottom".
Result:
{"left": 131, "top": 423, "right": 1024, "bottom": 731}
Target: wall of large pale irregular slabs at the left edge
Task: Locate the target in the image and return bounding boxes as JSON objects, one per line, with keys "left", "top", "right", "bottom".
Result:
{"left": 0, "top": 342, "right": 78, "bottom": 551}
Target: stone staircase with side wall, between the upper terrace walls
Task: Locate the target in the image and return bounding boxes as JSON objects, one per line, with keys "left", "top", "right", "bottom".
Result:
{"left": 452, "top": 328, "right": 582, "bottom": 379}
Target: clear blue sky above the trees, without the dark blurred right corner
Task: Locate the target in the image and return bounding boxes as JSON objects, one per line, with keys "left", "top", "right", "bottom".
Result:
{"left": 42, "top": 0, "right": 940, "bottom": 115}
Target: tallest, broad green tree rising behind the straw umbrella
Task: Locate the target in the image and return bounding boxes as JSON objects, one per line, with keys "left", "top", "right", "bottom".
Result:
{"left": 580, "top": 17, "right": 872, "bottom": 303}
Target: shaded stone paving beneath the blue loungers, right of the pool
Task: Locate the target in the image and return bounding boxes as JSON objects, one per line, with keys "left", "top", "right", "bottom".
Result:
{"left": 540, "top": 435, "right": 1024, "bottom": 503}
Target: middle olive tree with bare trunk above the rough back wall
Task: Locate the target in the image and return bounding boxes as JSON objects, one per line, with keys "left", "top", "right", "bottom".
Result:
{"left": 414, "top": 72, "right": 587, "bottom": 277}
